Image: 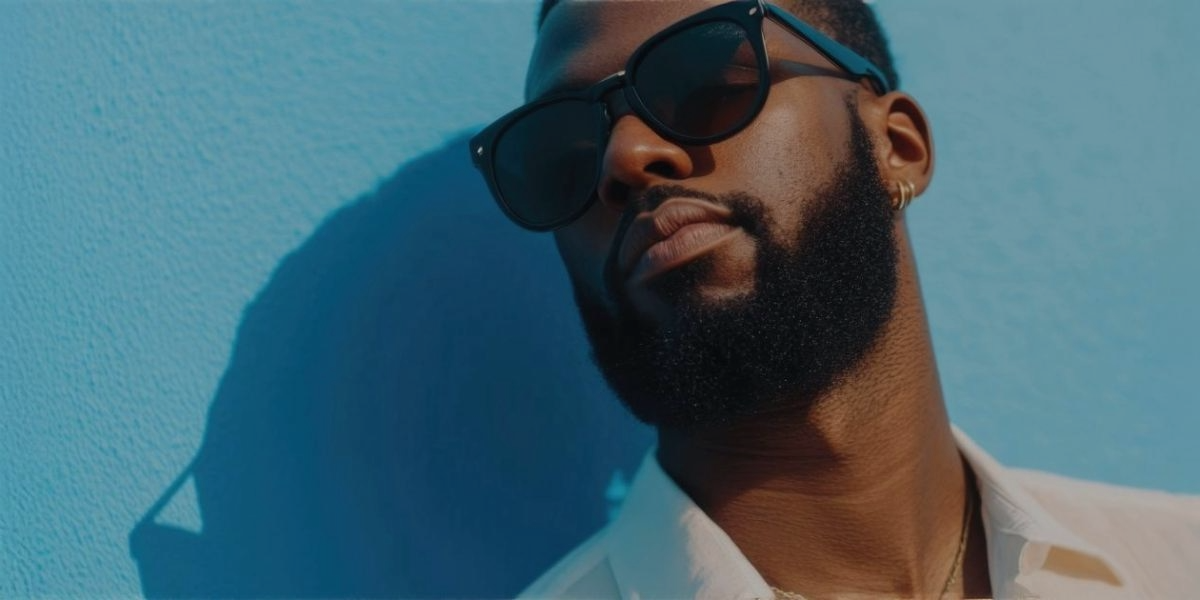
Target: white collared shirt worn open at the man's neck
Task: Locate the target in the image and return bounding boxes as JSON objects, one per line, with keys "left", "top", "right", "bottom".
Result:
{"left": 522, "top": 427, "right": 1200, "bottom": 600}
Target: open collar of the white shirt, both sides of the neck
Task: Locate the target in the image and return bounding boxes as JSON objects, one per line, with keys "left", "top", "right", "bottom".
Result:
{"left": 608, "top": 427, "right": 1128, "bottom": 600}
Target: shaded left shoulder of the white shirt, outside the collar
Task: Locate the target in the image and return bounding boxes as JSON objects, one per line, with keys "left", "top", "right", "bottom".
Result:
{"left": 518, "top": 527, "right": 620, "bottom": 599}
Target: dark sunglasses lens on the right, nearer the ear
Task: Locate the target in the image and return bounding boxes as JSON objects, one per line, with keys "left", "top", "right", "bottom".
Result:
{"left": 632, "top": 20, "right": 766, "bottom": 138}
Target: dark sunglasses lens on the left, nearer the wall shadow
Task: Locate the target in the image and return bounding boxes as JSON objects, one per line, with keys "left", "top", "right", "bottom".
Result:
{"left": 494, "top": 100, "right": 604, "bottom": 227}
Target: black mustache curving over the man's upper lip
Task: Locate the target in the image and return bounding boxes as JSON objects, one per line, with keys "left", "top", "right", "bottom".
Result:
{"left": 602, "top": 184, "right": 769, "bottom": 306}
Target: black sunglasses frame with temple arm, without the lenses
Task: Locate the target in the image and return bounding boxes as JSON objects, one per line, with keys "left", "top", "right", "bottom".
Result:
{"left": 470, "top": 0, "right": 892, "bottom": 232}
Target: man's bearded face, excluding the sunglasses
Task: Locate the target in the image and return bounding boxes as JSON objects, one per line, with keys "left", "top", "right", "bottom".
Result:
{"left": 527, "top": 1, "right": 896, "bottom": 427}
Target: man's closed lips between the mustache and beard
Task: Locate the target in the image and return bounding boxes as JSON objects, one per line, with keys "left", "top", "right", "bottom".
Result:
{"left": 617, "top": 198, "right": 737, "bottom": 280}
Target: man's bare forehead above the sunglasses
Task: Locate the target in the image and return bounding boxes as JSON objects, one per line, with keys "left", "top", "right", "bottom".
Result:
{"left": 526, "top": 0, "right": 727, "bottom": 98}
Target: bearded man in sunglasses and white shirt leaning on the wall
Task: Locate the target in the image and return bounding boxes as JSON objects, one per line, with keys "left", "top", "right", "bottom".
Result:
{"left": 470, "top": 0, "right": 1200, "bottom": 599}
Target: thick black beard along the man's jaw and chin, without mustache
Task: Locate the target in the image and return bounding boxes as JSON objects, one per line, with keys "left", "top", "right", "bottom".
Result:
{"left": 575, "top": 110, "right": 898, "bottom": 430}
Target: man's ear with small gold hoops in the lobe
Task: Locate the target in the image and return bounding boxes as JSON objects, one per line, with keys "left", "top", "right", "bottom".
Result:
{"left": 859, "top": 91, "right": 934, "bottom": 194}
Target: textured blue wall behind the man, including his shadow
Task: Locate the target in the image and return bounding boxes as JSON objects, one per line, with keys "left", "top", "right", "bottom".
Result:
{"left": 0, "top": 0, "right": 1200, "bottom": 598}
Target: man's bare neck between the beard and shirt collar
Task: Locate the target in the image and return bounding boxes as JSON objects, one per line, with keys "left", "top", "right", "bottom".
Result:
{"left": 658, "top": 228, "right": 986, "bottom": 599}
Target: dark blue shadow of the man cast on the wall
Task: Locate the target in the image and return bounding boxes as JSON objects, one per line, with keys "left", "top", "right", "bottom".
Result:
{"left": 130, "top": 137, "right": 652, "bottom": 598}
